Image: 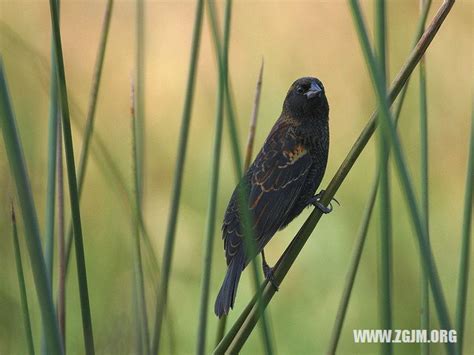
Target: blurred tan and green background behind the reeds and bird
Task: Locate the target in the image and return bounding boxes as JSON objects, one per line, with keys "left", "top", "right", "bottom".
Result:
{"left": 0, "top": 0, "right": 474, "bottom": 354}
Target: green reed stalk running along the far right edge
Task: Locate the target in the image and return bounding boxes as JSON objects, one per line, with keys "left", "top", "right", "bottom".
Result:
{"left": 455, "top": 103, "right": 474, "bottom": 354}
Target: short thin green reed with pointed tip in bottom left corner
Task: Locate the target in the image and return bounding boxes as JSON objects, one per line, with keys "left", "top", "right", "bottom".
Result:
{"left": 11, "top": 202, "right": 35, "bottom": 355}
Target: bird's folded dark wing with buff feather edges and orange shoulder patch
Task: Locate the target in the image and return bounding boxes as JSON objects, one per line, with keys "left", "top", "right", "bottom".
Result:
{"left": 223, "top": 124, "right": 312, "bottom": 262}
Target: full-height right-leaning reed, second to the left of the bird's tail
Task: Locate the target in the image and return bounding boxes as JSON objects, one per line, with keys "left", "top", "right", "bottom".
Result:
{"left": 151, "top": 0, "right": 204, "bottom": 354}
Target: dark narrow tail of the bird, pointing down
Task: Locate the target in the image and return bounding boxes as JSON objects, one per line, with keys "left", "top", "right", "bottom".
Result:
{"left": 214, "top": 252, "right": 245, "bottom": 318}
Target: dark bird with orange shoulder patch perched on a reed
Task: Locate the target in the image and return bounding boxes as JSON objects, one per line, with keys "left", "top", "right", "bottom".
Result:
{"left": 214, "top": 77, "right": 332, "bottom": 318}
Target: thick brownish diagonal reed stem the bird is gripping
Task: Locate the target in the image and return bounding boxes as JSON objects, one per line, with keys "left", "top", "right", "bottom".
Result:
{"left": 215, "top": 1, "right": 453, "bottom": 353}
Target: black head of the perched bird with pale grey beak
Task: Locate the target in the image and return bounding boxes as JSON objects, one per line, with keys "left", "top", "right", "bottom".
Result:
{"left": 283, "top": 77, "right": 329, "bottom": 120}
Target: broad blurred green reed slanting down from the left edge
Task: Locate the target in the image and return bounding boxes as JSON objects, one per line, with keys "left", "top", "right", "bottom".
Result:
{"left": 0, "top": 57, "right": 63, "bottom": 355}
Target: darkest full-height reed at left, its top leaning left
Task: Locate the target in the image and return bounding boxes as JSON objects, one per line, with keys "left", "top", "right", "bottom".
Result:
{"left": 48, "top": 0, "right": 95, "bottom": 355}
